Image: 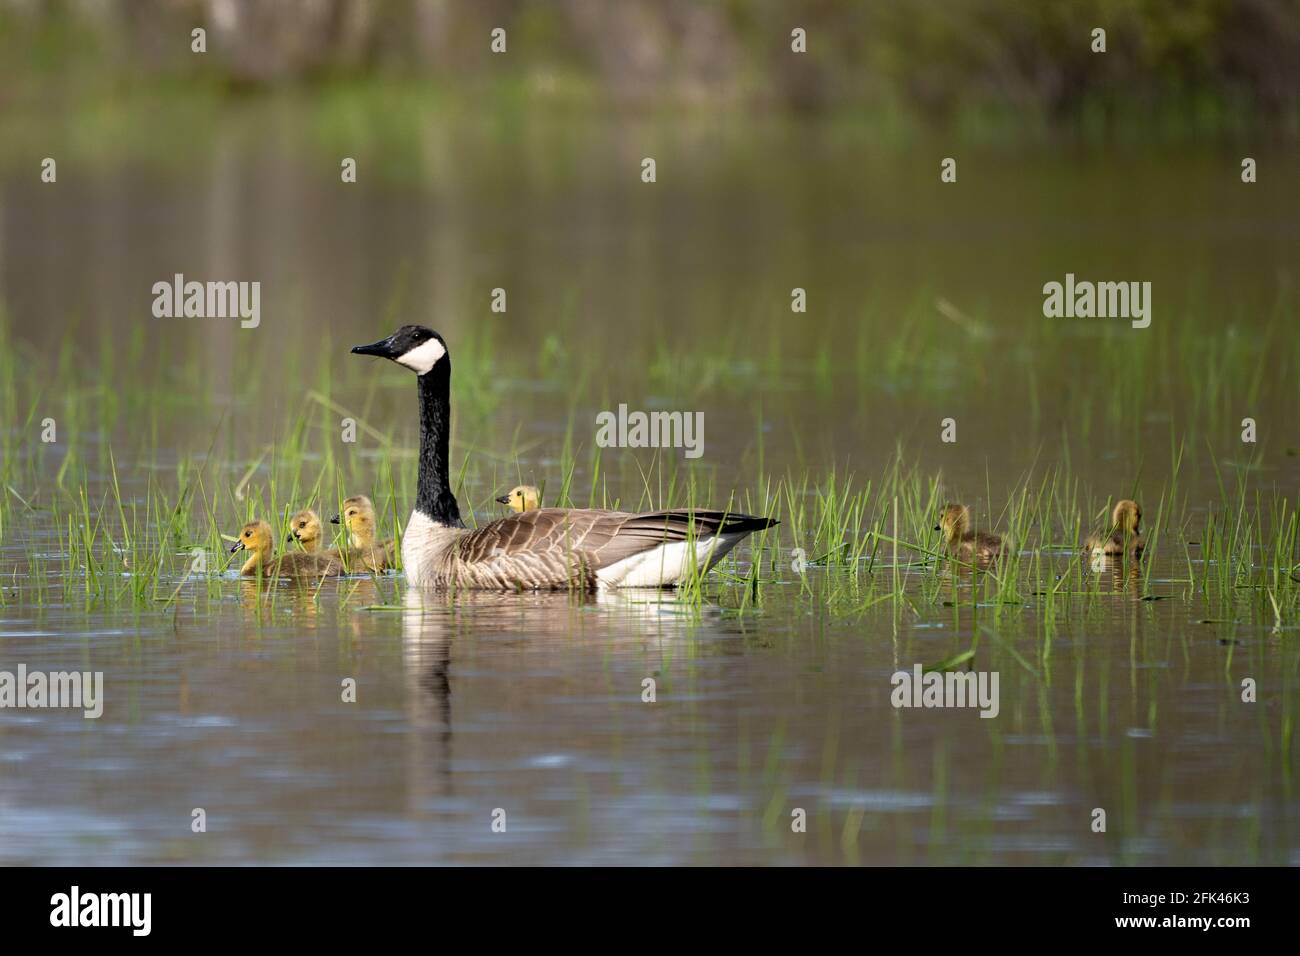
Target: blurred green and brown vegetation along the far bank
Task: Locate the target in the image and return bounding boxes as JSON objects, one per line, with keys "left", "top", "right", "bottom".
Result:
{"left": 0, "top": 0, "right": 1300, "bottom": 139}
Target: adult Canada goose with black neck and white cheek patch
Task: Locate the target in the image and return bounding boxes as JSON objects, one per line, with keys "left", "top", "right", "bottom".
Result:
{"left": 352, "top": 325, "right": 776, "bottom": 589}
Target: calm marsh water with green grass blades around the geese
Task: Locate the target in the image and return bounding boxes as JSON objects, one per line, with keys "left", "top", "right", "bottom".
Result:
{"left": 0, "top": 104, "right": 1300, "bottom": 865}
